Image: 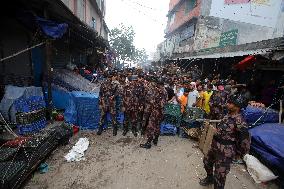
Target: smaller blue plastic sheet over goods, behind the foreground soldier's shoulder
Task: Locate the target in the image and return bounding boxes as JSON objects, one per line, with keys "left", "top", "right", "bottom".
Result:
{"left": 243, "top": 106, "right": 279, "bottom": 124}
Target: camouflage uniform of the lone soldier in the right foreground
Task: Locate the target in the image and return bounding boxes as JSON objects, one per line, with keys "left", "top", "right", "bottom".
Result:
{"left": 203, "top": 114, "right": 250, "bottom": 189}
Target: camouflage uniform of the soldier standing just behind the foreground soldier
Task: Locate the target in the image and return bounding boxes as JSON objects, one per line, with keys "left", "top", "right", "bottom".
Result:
{"left": 209, "top": 91, "right": 228, "bottom": 119}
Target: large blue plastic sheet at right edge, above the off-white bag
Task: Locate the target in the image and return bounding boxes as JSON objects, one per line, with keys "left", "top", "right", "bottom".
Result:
{"left": 249, "top": 123, "right": 284, "bottom": 180}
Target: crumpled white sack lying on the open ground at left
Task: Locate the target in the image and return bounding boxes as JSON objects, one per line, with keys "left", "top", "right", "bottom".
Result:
{"left": 64, "top": 138, "right": 89, "bottom": 162}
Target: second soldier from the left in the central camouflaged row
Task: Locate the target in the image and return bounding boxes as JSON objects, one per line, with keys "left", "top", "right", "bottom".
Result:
{"left": 122, "top": 75, "right": 139, "bottom": 137}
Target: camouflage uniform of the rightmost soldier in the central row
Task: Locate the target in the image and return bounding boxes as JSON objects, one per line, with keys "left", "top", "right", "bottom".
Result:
{"left": 146, "top": 87, "right": 168, "bottom": 141}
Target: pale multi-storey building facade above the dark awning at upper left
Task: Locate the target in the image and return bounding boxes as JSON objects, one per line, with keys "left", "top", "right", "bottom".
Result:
{"left": 62, "top": 0, "right": 109, "bottom": 39}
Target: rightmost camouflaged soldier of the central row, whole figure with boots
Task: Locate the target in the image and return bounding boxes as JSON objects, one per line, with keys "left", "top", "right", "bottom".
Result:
{"left": 140, "top": 79, "right": 168, "bottom": 149}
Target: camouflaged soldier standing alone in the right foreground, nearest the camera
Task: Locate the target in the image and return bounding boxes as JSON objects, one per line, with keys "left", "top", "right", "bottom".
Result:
{"left": 200, "top": 95, "right": 250, "bottom": 189}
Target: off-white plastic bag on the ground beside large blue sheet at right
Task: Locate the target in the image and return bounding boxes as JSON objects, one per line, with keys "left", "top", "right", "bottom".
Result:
{"left": 244, "top": 154, "right": 278, "bottom": 183}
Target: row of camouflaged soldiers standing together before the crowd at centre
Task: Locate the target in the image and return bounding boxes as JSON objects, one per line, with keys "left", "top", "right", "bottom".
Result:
{"left": 97, "top": 72, "right": 168, "bottom": 149}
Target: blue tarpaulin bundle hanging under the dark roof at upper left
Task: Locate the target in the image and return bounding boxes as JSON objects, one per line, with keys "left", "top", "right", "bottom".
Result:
{"left": 36, "top": 16, "right": 68, "bottom": 39}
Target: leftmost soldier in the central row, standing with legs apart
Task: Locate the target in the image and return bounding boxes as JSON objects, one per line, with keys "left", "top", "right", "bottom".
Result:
{"left": 97, "top": 72, "right": 118, "bottom": 136}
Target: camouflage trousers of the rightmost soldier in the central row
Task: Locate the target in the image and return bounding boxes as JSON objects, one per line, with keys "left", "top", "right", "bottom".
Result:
{"left": 146, "top": 110, "right": 163, "bottom": 140}
